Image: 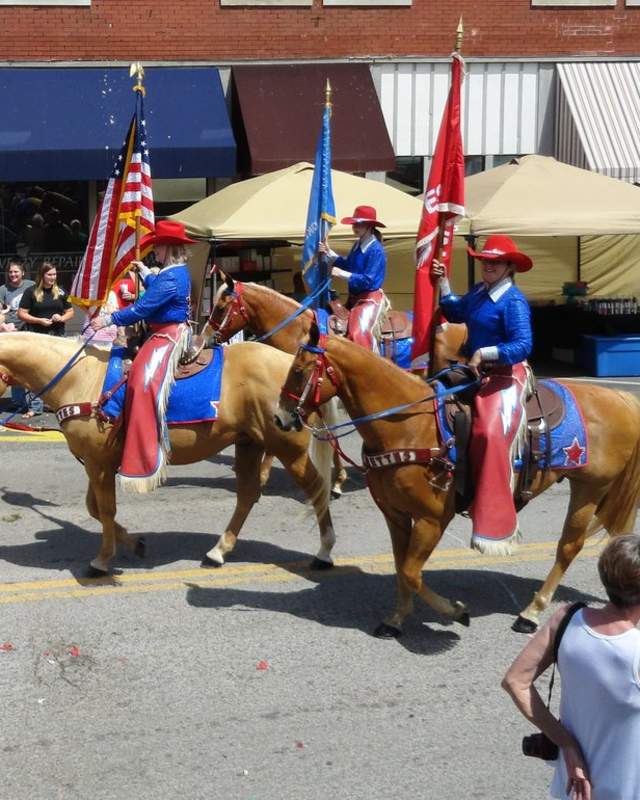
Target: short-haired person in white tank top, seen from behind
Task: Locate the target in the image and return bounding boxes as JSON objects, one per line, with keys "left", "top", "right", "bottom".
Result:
{"left": 502, "top": 534, "right": 640, "bottom": 800}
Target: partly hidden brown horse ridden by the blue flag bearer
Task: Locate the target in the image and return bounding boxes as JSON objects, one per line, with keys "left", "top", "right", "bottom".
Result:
{"left": 209, "top": 270, "right": 467, "bottom": 497}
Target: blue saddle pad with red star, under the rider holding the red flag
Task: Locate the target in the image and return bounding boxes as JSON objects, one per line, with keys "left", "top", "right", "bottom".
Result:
{"left": 436, "top": 380, "right": 589, "bottom": 471}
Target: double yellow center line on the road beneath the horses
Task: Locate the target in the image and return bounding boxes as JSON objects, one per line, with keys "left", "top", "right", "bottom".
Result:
{"left": 0, "top": 542, "right": 600, "bottom": 605}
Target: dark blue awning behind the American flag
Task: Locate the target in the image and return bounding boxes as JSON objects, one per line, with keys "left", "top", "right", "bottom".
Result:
{"left": 0, "top": 67, "right": 236, "bottom": 182}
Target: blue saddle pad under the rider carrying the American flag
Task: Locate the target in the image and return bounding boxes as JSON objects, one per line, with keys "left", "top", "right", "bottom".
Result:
{"left": 102, "top": 347, "right": 224, "bottom": 425}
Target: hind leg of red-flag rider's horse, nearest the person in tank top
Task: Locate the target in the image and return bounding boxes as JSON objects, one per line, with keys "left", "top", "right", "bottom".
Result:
{"left": 511, "top": 482, "right": 607, "bottom": 633}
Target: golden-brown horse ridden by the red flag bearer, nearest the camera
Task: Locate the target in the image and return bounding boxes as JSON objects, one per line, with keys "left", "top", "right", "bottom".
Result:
{"left": 277, "top": 326, "right": 640, "bottom": 637}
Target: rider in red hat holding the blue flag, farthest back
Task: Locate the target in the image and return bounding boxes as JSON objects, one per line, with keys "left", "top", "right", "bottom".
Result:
{"left": 318, "top": 206, "right": 387, "bottom": 350}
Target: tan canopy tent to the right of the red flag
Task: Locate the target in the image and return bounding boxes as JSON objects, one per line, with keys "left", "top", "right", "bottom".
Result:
{"left": 454, "top": 155, "right": 640, "bottom": 300}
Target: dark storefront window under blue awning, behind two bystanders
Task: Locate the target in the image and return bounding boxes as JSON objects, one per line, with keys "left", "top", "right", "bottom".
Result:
{"left": 0, "top": 181, "right": 89, "bottom": 288}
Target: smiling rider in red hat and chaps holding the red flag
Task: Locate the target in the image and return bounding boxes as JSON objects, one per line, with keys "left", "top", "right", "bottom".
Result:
{"left": 432, "top": 236, "right": 533, "bottom": 550}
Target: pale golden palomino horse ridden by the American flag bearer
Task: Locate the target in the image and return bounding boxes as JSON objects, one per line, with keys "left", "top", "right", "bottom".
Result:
{"left": 0, "top": 333, "right": 335, "bottom": 576}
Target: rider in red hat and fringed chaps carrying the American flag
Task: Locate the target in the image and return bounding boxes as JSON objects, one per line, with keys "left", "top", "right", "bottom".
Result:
{"left": 91, "top": 220, "right": 195, "bottom": 492}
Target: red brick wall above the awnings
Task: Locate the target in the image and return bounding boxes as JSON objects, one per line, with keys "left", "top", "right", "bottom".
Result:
{"left": 0, "top": 0, "right": 640, "bottom": 63}
